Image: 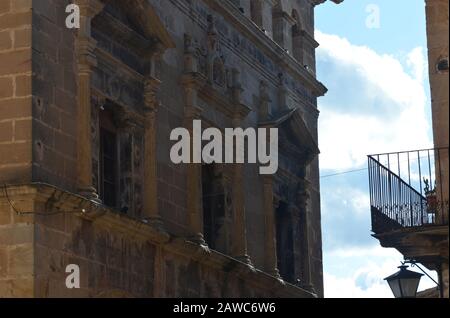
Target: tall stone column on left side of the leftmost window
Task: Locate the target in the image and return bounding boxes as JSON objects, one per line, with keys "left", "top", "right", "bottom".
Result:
{"left": 75, "top": 0, "right": 104, "bottom": 200}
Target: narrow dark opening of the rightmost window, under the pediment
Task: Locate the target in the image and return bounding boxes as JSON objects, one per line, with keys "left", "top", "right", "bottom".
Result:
{"left": 275, "top": 202, "right": 295, "bottom": 283}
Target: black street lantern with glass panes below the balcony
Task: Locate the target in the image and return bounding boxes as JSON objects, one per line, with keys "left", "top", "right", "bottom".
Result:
{"left": 385, "top": 265, "right": 423, "bottom": 298}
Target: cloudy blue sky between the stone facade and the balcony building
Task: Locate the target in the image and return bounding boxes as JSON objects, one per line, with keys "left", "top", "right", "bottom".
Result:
{"left": 316, "top": 0, "right": 433, "bottom": 297}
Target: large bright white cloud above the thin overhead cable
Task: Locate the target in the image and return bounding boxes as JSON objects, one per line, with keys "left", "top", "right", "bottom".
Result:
{"left": 316, "top": 31, "right": 432, "bottom": 170}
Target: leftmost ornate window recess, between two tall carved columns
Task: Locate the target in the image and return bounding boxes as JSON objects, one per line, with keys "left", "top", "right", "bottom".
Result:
{"left": 91, "top": 101, "right": 144, "bottom": 217}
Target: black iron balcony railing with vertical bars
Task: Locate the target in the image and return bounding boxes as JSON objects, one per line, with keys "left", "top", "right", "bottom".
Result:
{"left": 368, "top": 147, "right": 449, "bottom": 234}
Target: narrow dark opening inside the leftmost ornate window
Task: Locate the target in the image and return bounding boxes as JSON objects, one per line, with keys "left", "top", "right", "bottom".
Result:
{"left": 100, "top": 110, "right": 118, "bottom": 207}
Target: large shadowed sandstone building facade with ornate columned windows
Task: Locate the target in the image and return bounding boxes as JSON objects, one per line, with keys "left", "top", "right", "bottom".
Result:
{"left": 0, "top": 0, "right": 341, "bottom": 297}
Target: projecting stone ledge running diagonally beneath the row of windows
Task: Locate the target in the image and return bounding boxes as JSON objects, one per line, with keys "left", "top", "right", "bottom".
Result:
{"left": 0, "top": 183, "right": 317, "bottom": 298}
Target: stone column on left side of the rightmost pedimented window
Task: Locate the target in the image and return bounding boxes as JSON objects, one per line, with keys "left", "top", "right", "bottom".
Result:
{"left": 263, "top": 176, "right": 281, "bottom": 279}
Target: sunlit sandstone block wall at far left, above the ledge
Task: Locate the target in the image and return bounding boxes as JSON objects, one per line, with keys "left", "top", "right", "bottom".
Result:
{"left": 0, "top": 0, "right": 32, "bottom": 183}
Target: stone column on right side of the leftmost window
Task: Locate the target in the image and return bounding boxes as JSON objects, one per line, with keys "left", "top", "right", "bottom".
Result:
{"left": 144, "top": 76, "right": 162, "bottom": 229}
